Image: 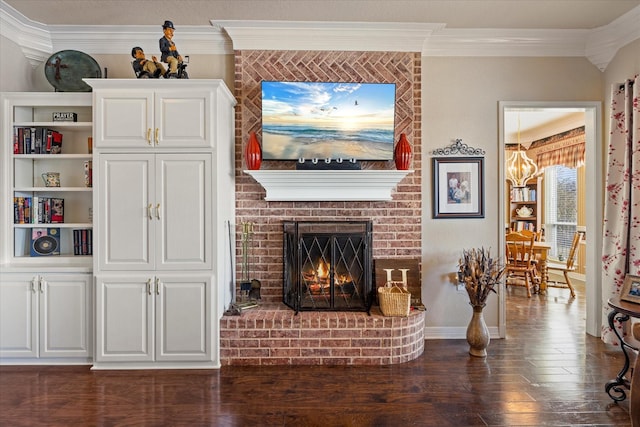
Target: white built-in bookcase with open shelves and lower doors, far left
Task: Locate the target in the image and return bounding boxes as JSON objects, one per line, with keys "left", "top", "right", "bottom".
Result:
{"left": 0, "top": 92, "right": 93, "bottom": 364}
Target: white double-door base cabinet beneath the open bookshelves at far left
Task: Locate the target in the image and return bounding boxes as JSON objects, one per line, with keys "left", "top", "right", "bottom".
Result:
{"left": 0, "top": 273, "right": 92, "bottom": 364}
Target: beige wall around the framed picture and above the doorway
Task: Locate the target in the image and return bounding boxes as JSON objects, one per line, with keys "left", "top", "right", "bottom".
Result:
{"left": 422, "top": 57, "right": 603, "bottom": 338}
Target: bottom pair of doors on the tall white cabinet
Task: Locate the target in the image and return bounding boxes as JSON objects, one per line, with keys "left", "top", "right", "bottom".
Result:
{"left": 96, "top": 273, "right": 212, "bottom": 363}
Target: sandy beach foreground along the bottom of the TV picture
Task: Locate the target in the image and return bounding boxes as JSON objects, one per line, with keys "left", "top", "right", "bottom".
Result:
{"left": 262, "top": 130, "right": 393, "bottom": 160}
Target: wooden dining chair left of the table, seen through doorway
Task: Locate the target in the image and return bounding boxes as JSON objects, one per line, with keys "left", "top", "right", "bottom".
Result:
{"left": 505, "top": 232, "right": 540, "bottom": 298}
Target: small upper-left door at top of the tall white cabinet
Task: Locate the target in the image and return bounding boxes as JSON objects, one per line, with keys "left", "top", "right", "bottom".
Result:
{"left": 94, "top": 90, "right": 155, "bottom": 148}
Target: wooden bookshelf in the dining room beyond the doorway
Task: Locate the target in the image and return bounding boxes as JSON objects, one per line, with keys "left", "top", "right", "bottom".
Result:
{"left": 509, "top": 178, "right": 542, "bottom": 236}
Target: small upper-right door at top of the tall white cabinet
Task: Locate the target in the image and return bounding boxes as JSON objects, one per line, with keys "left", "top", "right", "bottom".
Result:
{"left": 154, "top": 90, "right": 213, "bottom": 148}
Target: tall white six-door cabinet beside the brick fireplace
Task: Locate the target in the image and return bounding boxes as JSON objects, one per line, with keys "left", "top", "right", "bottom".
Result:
{"left": 87, "top": 79, "right": 235, "bottom": 369}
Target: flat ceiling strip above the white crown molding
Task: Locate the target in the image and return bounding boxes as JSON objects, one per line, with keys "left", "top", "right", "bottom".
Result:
{"left": 3, "top": 0, "right": 640, "bottom": 30}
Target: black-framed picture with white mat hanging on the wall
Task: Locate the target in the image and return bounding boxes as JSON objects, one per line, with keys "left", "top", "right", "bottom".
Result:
{"left": 432, "top": 157, "right": 484, "bottom": 218}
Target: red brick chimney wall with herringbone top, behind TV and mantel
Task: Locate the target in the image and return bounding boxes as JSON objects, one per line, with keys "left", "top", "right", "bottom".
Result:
{"left": 234, "top": 50, "right": 422, "bottom": 302}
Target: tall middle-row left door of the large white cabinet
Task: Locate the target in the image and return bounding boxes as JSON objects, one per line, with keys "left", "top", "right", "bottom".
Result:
{"left": 99, "top": 154, "right": 156, "bottom": 270}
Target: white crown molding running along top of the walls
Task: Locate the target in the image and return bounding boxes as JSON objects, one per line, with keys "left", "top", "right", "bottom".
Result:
{"left": 0, "top": 0, "right": 640, "bottom": 71}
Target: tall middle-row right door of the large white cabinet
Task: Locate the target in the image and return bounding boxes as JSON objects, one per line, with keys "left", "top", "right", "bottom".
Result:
{"left": 154, "top": 154, "right": 211, "bottom": 270}
